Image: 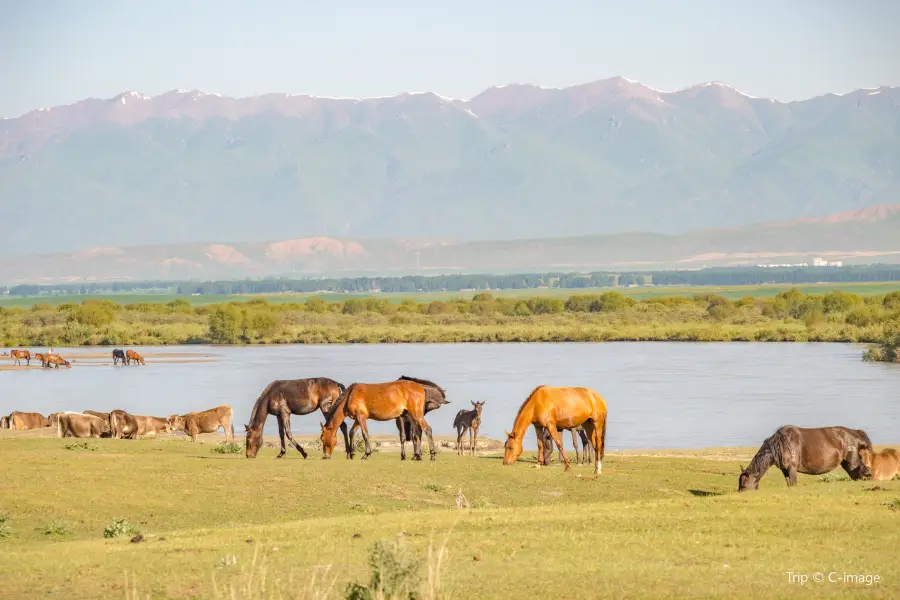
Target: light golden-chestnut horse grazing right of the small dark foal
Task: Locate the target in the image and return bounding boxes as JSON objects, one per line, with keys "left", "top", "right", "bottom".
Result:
{"left": 503, "top": 385, "right": 606, "bottom": 475}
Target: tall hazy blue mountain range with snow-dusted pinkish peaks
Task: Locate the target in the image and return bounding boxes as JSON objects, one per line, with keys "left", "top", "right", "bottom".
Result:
{"left": 0, "top": 77, "right": 900, "bottom": 255}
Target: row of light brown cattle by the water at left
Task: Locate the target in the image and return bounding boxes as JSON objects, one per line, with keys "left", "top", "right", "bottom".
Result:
{"left": 0, "top": 405, "right": 234, "bottom": 442}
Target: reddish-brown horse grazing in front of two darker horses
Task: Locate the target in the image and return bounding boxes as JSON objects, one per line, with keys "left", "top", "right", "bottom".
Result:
{"left": 321, "top": 380, "right": 437, "bottom": 460}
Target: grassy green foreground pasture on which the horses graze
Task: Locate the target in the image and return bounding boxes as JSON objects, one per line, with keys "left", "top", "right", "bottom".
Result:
{"left": 0, "top": 431, "right": 900, "bottom": 599}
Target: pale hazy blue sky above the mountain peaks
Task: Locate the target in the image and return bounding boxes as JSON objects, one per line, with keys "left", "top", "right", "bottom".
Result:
{"left": 0, "top": 0, "right": 900, "bottom": 117}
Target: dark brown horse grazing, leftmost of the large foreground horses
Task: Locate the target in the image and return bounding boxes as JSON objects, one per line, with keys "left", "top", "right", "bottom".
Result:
{"left": 244, "top": 377, "right": 350, "bottom": 458}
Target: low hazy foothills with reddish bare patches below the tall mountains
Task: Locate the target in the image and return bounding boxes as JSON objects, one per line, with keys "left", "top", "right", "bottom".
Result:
{"left": 0, "top": 204, "right": 900, "bottom": 285}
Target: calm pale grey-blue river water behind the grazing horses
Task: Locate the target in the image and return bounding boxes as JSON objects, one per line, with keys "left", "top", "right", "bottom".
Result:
{"left": 0, "top": 342, "right": 900, "bottom": 449}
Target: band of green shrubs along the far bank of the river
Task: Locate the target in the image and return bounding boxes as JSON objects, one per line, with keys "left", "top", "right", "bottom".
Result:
{"left": 0, "top": 290, "right": 900, "bottom": 348}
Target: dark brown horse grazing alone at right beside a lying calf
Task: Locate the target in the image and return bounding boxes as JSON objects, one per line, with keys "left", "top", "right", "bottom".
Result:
{"left": 738, "top": 425, "right": 872, "bottom": 492}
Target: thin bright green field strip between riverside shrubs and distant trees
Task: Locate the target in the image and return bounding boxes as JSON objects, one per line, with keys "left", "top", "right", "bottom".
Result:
{"left": 0, "top": 281, "right": 900, "bottom": 307}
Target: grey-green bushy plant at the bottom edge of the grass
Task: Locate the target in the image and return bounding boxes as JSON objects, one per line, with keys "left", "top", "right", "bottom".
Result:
{"left": 346, "top": 540, "right": 424, "bottom": 600}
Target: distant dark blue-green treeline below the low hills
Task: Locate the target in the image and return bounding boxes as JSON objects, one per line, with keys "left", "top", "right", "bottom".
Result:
{"left": 9, "top": 265, "right": 900, "bottom": 296}
